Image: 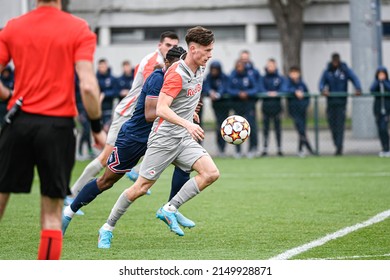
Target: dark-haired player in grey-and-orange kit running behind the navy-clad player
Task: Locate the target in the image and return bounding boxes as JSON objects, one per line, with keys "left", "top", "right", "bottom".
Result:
{"left": 65, "top": 31, "right": 179, "bottom": 209}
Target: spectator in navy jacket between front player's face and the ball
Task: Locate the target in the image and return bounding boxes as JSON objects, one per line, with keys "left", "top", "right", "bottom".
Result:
{"left": 202, "top": 61, "right": 230, "bottom": 157}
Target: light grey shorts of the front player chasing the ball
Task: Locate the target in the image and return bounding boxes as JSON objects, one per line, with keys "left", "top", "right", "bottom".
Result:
{"left": 139, "top": 136, "right": 210, "bottom": 181}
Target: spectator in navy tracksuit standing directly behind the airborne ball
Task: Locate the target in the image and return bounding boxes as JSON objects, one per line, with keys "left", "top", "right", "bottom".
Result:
{"left": 228, "top": 60, "right": 258, "bottom": 158}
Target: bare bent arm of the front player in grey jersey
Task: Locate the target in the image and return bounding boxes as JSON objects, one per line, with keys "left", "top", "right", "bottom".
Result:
{"left": 156, "top": 92, "right": 204, "bottom": 141}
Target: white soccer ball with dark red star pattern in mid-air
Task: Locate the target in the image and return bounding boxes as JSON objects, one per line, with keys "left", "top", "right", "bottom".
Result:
{"left": 221, "top": 115, "right": 251, "bottom": 145}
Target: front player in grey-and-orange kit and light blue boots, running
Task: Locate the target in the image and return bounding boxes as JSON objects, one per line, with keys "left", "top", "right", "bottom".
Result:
{"left": 98, "top": 26, "right": 219, "bottom": 248}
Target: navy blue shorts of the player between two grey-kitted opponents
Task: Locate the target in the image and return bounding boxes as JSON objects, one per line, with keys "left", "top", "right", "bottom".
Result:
{"left": 107, "top": 138, "right": 147, "bottom": 174}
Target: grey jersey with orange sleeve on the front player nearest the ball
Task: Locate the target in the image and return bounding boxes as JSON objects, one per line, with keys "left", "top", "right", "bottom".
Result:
{"left": 150, "top": 59, "right": 204, "bottom": 139}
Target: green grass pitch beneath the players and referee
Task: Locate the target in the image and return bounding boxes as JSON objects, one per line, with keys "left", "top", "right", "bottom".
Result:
{"left": 0, "top": 156, "right": 390, "bottom": 260}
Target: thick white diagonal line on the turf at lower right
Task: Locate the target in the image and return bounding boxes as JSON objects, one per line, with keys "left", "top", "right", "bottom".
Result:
{"left": 270, "top": 209, "right": 390, "bottom": 260}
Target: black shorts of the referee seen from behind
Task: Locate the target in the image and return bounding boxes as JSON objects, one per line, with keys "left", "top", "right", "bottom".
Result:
{"left": 0, "top": 112, "right": 76, "bottom": 198}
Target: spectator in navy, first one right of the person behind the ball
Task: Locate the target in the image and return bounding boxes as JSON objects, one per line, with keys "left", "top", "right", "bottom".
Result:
{"left": 261, "top": 58, "right": 284, "bottom": 156}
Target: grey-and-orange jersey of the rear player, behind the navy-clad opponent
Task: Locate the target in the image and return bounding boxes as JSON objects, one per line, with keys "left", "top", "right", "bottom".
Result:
{"left": 115, "top": 49, "right": 164, "bottom": 117}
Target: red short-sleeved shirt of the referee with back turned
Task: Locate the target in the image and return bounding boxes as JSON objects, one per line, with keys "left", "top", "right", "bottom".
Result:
{"left": 0, "top": 6, "right": 96, "bottom": 117}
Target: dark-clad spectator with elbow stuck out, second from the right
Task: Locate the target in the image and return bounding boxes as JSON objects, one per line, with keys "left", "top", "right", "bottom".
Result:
{"left": 319, "top": 53, "right": 362, "bottom": 156}
